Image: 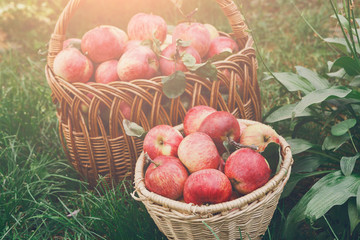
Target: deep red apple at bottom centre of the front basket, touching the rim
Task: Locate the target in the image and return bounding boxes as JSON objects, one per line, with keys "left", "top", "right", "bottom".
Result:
{"left": 184, "top": 169, "right": 232, "bottom": 205}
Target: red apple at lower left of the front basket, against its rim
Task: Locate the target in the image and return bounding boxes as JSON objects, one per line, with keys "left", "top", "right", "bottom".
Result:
{"left": 145, "top": 156, "right": 189, "bottom": 200}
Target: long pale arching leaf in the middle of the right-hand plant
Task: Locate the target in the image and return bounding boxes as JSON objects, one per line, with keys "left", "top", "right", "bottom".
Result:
{"left": 293, "top": 86, "right": 351, "bottom": 117}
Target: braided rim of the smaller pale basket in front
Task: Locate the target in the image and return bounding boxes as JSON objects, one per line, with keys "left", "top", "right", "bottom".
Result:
{"left": 132, "top": 119, "right": 293, "bottom": 215}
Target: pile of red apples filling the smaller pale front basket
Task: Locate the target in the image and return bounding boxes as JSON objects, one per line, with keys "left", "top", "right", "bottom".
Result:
{"left": 143, "top": 105, "right": 279, "bottom": 205}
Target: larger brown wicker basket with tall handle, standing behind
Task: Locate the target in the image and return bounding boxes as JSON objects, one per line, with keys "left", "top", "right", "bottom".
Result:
{"left": 45, "top": 0, "right": 261, "bottom": 185}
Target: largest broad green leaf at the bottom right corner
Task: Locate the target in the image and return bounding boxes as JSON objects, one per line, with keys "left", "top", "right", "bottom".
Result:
{"left": 284, "top": 171, "right": 360, "bottom": 239}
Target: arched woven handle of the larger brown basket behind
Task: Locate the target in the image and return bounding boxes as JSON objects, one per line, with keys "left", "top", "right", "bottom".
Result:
{"left": 47, "top": 0, "right": 248, "bottom": 68}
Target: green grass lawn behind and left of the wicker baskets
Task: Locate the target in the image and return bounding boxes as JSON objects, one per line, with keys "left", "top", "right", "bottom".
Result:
{"left": 0, "top": 0, "right": 342, "bottom": 240}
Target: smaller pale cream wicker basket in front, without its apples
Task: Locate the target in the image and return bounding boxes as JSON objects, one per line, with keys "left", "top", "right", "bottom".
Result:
{"left": 132, "top": 120, "right": 293, "bottom": 240}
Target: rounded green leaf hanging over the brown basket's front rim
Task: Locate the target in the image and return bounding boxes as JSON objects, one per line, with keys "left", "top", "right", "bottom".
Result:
{"left": 162, "top": 71, "right": 186, "bottom": 98}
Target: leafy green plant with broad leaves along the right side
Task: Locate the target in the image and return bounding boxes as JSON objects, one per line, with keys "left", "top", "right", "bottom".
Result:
{"left": 265, "top": 0, "right": 360, "bottom": 239}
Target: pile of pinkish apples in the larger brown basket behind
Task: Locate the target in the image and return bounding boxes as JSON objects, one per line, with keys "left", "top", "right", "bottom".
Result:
{"left": 53, "top": 13, "right": 239, "bottom": 84}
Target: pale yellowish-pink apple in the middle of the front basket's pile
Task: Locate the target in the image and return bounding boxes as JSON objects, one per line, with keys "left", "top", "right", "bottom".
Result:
{"left": 178, "top": 132, "right": 221, "bottom": 173}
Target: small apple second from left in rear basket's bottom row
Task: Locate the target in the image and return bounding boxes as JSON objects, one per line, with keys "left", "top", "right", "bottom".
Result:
{"left": 95, "top": 59, "right": 120, "bottom": 84}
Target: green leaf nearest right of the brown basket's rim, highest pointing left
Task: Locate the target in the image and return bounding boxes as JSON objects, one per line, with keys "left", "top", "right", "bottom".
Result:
{"left": 264, "top": 72, "right": 315, "bottom": 94}
